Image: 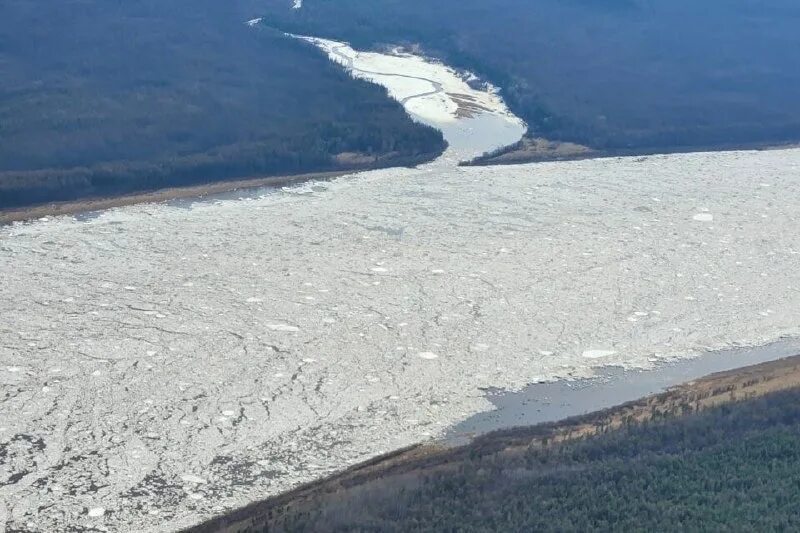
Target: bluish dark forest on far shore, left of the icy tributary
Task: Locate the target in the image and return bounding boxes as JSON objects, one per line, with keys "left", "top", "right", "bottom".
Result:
{"left": 0, "top": 0, "right": 445, "bottom": 208}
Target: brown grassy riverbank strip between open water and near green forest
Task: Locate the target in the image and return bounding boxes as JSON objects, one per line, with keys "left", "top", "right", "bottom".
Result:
{"left": 184, "top": 355, "right": 800, "bottom": 533}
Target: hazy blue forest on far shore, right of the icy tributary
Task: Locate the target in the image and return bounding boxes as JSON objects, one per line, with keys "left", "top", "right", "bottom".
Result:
{"left": 267, "top": 0, "right": 800, "bottom": 153}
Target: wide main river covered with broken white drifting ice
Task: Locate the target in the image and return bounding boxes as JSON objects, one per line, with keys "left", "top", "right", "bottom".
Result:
{"left": 0, "top": 36, "right": 800, "bottom": 531}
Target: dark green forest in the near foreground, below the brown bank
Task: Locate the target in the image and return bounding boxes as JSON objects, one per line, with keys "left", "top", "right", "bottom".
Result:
{"left": 268, "top": 389, "right": 800, "bottom": 532}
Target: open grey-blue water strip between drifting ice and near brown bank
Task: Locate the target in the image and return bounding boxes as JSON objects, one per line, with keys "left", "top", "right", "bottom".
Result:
{"left": 445, "top": 339, "right": 800, "bottom": 444}
